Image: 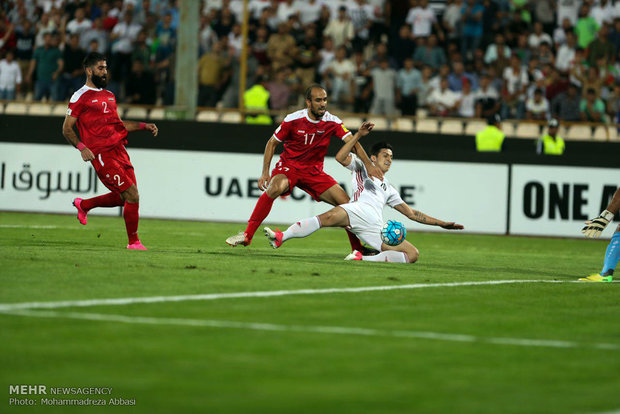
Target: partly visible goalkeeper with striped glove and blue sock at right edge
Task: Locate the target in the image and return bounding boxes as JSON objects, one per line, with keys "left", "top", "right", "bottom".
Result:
{"left": 579, "top": 188, "right": 620, "bottom": 282}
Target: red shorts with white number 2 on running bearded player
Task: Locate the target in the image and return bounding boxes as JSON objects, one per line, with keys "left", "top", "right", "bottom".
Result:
{"left": 91, "top": 145, "right": 136, "bottom": 194}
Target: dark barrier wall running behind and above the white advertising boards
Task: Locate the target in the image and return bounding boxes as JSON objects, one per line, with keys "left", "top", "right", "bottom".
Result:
{"left": 0, "top": 115, "right": 620, "bottom": 168}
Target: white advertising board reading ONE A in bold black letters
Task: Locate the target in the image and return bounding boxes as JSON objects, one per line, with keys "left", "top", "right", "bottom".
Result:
{"left": 510, "top": 165, "right": 620, "bottom": 237}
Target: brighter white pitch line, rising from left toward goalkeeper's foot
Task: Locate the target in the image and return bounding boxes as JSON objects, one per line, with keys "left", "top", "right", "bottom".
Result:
{"left": 0, "top": 280, "right": 583, "bottom": 312}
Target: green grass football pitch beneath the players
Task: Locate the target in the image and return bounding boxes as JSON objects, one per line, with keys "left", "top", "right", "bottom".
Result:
{"left": 0, "top": 213, "right": 620, "bottom": 414}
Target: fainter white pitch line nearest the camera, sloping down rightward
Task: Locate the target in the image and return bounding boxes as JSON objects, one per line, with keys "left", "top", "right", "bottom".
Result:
{"left": 5, "top": 310, "right": 620, "bottom": 350}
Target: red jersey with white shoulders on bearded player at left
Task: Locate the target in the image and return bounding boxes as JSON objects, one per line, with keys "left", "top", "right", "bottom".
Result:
{"left": 67, "top": 85, "right": 127, "bottom": 155}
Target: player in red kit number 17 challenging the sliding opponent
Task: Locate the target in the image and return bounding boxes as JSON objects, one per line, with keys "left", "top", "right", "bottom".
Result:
{"left": 226, "top": 85, "right": 383, "bottom": 250}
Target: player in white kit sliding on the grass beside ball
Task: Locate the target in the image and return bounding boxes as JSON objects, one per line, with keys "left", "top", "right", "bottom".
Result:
{"left": 265, "top": 124, "right": 463, "bottom": 263}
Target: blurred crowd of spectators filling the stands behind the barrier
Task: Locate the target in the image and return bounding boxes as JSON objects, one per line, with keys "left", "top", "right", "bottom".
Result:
{"left": 0, "top": 0, "right": 620, "bottom": 122}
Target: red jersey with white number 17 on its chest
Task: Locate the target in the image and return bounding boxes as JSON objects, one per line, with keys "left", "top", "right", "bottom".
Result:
{"left": 273, "top": 109, "right": 351, "bottom": 171}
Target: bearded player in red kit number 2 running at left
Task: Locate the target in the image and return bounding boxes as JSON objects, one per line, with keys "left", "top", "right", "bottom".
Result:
{"left": 62, "top": 53, "right": 158, "bottom": 250}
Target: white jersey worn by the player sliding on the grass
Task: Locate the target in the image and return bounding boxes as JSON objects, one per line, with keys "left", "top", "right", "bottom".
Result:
{"left": 347, "top": 153, "right": 404, "bottom": 224}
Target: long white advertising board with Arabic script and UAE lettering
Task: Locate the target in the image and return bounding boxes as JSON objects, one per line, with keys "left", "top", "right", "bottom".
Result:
{"left": 0, "top": 143, "right": 508, "bottom": 234}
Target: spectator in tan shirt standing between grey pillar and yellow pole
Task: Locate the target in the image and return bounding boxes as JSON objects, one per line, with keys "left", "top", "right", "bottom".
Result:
{"left": 198, "top": 42, "right": 228, "bottom": 107}
